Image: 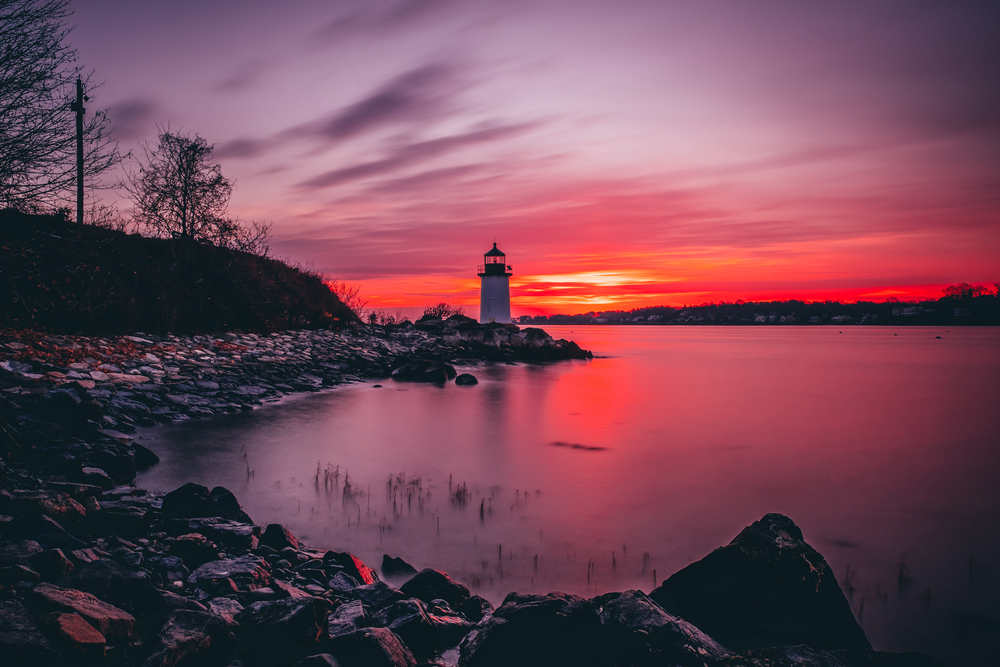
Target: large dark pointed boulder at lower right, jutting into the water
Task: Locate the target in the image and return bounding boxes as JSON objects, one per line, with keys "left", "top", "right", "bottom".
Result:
{"left": 650, "top": 514, "right": 871, "bottom": 650}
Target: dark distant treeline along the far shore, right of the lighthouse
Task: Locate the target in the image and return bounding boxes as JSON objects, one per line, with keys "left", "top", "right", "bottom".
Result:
{"left": 517, "top": 283, "right": 1000, "bottom": 326}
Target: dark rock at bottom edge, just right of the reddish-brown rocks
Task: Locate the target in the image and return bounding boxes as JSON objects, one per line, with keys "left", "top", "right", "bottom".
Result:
{"left": 142, "top": 610, "right": 236, "bottom": 667}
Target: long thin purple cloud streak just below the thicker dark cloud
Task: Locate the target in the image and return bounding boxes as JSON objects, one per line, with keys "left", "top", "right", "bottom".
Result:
{"left": 298, "top": 123, "right": 534, "bottom": 190}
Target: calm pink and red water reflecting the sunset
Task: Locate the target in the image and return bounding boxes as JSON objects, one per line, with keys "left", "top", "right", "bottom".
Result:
{"left": 140, "top": 327, "right": 1000, "bottom": 664}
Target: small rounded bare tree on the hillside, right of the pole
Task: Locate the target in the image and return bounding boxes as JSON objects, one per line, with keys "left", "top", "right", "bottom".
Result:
{"left": 121, "top": 127, "right": 271, "bottom": 255}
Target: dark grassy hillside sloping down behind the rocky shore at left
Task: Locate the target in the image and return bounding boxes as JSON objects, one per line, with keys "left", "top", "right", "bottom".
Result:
{"left": 0, "top": 209, "right": 357, "bottom": 335}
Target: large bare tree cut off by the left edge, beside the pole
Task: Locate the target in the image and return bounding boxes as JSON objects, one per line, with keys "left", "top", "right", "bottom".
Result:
{"left": 0, "top": 0, "right": 121, "bottom": 209}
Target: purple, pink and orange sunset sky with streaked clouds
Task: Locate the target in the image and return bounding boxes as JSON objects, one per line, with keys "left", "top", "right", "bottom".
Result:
{"left": 70, "top": 0, "right": 1000, "bottom": 316}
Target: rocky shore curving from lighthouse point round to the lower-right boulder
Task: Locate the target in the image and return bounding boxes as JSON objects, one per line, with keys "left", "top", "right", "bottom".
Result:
{"left": 0, "top": 317, "right": 939, "bottom": 667}
